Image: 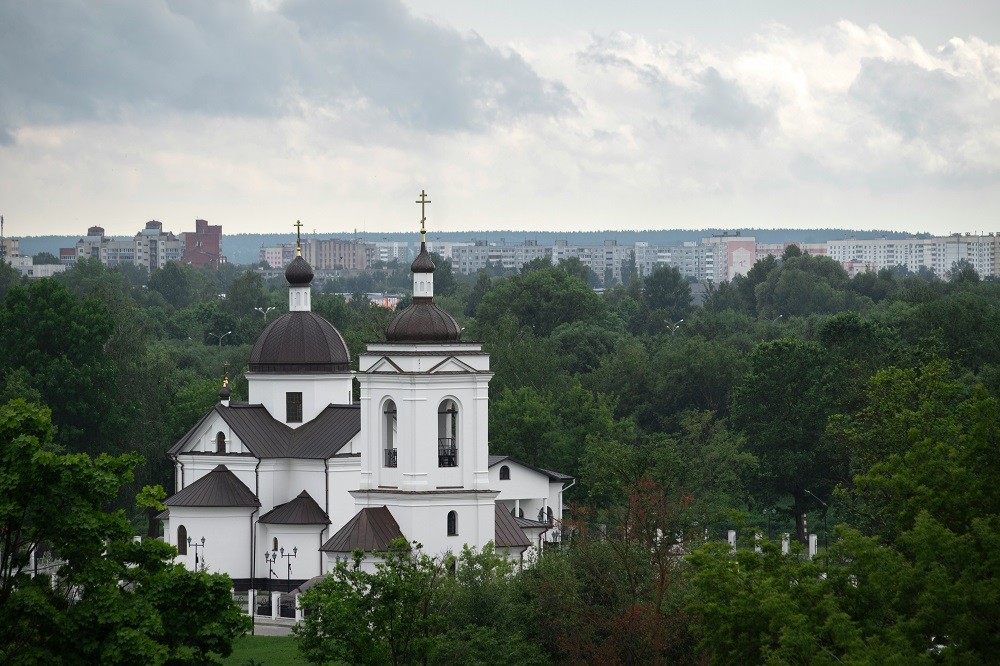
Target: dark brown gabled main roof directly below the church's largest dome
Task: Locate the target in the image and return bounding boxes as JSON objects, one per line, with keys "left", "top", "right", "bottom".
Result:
{"left": 170, "top": 404, "right": 361, "bottom": 460}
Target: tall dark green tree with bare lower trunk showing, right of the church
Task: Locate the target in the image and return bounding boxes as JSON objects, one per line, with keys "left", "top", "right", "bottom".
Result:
{"left": 730, "top": 338, "right": 847, "bottom": 541}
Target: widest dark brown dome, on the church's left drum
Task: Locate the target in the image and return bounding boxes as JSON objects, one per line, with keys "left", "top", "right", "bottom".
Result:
{"left": 250, "top": 310, "right": 351, "bottom": 374}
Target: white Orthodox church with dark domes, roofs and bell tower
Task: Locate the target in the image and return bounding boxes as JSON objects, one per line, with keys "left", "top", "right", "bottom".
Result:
{"left": 159, "top": 200, "right": 573, "bottom": 589}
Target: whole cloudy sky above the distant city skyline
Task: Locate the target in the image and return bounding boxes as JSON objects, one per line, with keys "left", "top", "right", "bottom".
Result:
{"left": 0, "top": 0, "right": 1000, "bottom": 236}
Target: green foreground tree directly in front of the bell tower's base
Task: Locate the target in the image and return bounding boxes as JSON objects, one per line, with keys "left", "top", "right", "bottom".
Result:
{"left": 293, "top": 539, "right": 444, "bottom": 665}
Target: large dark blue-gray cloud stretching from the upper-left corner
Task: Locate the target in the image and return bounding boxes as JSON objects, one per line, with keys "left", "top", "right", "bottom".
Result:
{"left": 0, "top": 0, "right": 572, "bottom": 138}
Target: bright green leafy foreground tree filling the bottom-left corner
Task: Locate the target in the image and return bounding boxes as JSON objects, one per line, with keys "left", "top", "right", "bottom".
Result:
{"left": 0, "top": 399, "right": 249, "bottom": 664}
